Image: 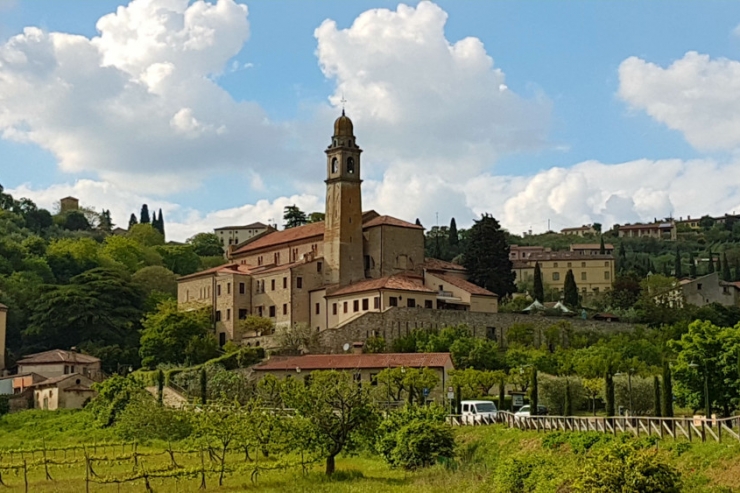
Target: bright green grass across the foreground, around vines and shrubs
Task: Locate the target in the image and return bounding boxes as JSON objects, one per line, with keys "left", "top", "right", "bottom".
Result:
{"left": 0, "top": 411, "right": 740, "bottom": 493}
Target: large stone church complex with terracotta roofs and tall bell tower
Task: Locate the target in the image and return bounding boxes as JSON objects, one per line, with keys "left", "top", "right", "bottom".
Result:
{"left": 178, "top": 111, "right": 498, "bottom": 345}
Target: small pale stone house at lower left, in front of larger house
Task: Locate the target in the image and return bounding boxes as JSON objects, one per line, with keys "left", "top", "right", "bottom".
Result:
{"left": 33, "top": 373, "right": 96, "bottom": 411}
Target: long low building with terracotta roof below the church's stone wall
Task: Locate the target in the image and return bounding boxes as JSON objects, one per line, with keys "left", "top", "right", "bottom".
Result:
{"left": 253, "top": 353, "right": 455, "bottom": 398}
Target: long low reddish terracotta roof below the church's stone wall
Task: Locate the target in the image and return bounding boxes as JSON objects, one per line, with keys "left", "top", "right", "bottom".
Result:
{"left": 253, "top": 353, "right": 452, "bottom": 371}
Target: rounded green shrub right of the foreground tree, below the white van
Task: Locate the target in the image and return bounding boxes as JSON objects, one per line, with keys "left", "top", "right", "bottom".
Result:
{"left": 389, "top": 420, "right": 455, "bottom": 470}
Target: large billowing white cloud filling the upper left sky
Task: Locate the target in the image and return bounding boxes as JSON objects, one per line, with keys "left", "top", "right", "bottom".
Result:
{"left": 0, "top": 0, "right": 284, "bottom": 194}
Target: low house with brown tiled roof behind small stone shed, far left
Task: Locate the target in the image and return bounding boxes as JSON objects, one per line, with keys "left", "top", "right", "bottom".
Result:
{"left": 18, "top": 349, "right": 103, "bottom": 381}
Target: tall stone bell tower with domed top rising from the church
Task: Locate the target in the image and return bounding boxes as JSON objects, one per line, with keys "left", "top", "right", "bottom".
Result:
{"left": 324, "top": 110, "right": 365, "bottom": 286}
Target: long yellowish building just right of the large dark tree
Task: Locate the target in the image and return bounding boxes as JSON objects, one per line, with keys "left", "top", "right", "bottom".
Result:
{"left": 510, "top": 245, "right": 614, "bottom": 296}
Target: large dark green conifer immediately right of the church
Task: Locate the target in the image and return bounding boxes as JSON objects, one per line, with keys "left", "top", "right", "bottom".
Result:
{"left": 464, "top": 214, "right": 516, "bottom": 297}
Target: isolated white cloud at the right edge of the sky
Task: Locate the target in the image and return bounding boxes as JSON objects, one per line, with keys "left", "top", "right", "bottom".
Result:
{"left": 619, "top": 51, "right": 740, "bottom": 150}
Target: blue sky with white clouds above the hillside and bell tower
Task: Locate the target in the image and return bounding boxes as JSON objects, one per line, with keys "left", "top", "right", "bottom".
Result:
{"left": 0, "top": 0, "right": 740, "bottom": 241}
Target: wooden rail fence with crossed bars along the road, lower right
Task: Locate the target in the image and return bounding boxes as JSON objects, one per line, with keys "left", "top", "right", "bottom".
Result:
{"left": 448, "top": 411, "right": 740, "bottom": 443}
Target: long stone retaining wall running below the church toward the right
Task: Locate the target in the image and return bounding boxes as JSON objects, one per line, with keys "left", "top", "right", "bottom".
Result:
{"left": 312, "top": 307, "right": 634, "bottom": 353}
